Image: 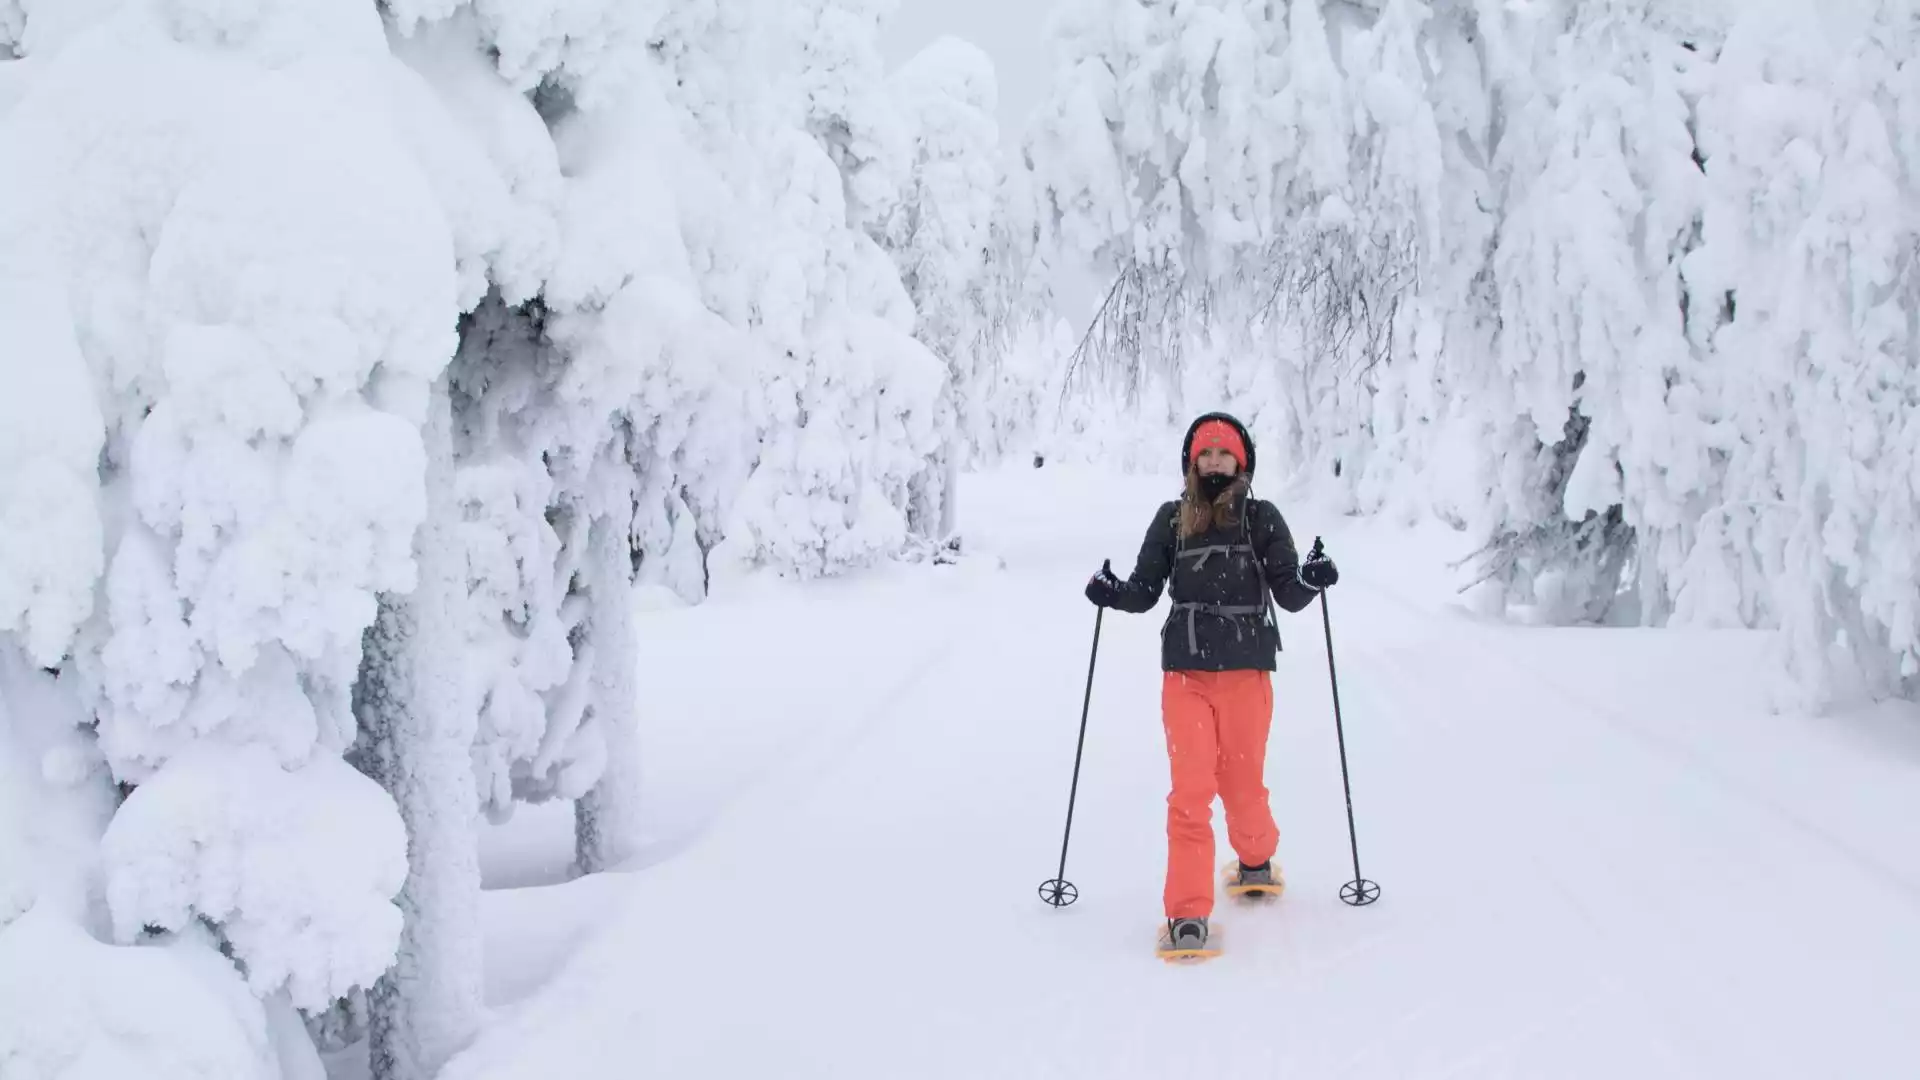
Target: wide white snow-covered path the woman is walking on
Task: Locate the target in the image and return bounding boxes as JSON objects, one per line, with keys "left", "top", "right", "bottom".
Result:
{"left": 449, "top": 469, "right": 1920, "bottom": 1080}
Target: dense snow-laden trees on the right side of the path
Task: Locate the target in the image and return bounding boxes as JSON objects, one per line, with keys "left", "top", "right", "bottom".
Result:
{"left": 1008, "top": 0, "right": 1920, "bottom": 705}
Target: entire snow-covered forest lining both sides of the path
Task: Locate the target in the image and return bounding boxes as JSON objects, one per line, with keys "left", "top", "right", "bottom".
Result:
{"left": 0, "top": 0, "right": 1920, "bottom": 1080}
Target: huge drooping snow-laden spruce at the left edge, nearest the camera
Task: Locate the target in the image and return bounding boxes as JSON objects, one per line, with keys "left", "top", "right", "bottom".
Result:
{"left": 0, "top": 2, "right": 455, "bottom": 1005}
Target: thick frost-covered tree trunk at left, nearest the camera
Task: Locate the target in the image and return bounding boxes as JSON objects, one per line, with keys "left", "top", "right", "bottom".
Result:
{"left": 353, "top": 379, "right": 482, "bottom": 1080}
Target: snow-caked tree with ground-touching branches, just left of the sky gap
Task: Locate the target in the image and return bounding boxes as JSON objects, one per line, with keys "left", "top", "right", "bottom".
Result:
{"left": 676, "top": 0, "right": 943, "bottom": 577}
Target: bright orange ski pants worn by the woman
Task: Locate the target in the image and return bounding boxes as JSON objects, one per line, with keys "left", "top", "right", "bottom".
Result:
{"left": 1160, "top": 671, "right": 1281, "bottom": 919}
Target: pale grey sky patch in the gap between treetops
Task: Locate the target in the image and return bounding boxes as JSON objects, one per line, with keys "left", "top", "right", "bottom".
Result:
{"left": 879, "top": 0, "right": 1060, "bottom": 146}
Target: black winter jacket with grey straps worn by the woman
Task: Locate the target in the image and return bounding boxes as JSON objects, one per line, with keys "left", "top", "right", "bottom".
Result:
{"left": 1114, "top": 500, "right": 1317, "bottom": 671}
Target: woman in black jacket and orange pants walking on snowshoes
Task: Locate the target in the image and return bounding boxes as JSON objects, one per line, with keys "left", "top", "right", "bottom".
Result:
{"left": 1087, "top": 413, "right": 1340, "bottom": 951}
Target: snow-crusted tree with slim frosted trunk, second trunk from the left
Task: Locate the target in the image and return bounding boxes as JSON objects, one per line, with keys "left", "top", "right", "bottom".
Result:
{"left": 522, "top": 48, "right": 745, "bottom": 871}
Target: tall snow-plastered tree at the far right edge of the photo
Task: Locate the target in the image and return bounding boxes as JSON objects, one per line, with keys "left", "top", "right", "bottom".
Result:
{"left": 1676, "top": 0, "right": 1920, "bottom": 703}
